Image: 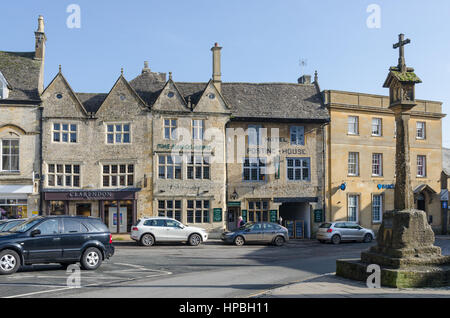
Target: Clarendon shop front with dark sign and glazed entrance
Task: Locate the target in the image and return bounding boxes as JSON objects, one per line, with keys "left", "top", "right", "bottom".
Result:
{"left": 44, "top": 189, "right": 140, "bottom": 233}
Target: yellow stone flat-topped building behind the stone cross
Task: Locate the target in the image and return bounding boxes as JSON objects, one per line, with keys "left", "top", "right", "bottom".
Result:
{"left": 324, "top": 90, "right": 445, "bottom": 233}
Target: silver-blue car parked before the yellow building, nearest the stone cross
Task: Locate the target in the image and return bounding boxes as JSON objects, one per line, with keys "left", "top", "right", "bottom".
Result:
{"left": 317, "top": 222, "right": 375, "bottom": 244}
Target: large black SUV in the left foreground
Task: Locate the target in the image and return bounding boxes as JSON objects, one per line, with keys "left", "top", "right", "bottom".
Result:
{"left": 0, "top": 216, "right": 114, "bottom": 275}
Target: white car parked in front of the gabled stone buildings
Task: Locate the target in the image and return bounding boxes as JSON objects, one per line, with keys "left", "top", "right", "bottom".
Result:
{"left": 130, "top": 217, "right": 208, "bottom": 246}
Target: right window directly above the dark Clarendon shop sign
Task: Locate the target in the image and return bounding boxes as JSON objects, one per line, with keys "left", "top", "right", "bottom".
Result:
{"left": 102, "top": 163, "right": 134, "bottom": 188}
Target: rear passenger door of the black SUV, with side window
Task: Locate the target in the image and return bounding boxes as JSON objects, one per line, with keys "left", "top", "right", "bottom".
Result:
{"left": 61, "top": 218, "right": 89, "bottom": 260}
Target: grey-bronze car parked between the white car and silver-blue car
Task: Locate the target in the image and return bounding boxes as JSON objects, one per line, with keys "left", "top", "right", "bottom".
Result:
{"left": 222, "top": 222, "right": 289, "bottom": 246}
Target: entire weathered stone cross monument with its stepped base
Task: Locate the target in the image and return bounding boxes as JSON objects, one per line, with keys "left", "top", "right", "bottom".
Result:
{"left": 336, "top": 34, "right": 450, "bottom": 287}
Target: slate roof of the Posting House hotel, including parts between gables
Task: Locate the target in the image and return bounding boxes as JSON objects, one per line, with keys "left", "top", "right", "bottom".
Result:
{"left": 125, "top": 73, "right": 330, "bottom": 121}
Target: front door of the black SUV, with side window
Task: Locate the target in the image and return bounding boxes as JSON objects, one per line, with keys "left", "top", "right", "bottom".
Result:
{"left": 24, "top": 218, "right": 62, "bottom": 262}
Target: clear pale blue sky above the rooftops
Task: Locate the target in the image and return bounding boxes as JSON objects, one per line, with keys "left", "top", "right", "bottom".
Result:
{"left": 0, "top": 0, "right": 450, "bottom": 148}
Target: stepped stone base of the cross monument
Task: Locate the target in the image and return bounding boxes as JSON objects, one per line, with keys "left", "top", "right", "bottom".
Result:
{"left": 336, "top": 210, "right": 450, "bottom": 288}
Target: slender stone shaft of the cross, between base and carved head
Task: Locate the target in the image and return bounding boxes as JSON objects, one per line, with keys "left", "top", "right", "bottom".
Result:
{"left": 394, "top": 112, "right": 414, "bottom": 211}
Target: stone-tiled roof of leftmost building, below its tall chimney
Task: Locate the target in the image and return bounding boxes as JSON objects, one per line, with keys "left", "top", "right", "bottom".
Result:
{"left": 0, "top": 51, "right": 41, "bottom": 100}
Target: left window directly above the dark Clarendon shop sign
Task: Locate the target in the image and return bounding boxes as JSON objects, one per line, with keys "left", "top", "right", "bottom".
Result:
{"left": 47, "top": 163, "right": 81, "bottom": 188}
